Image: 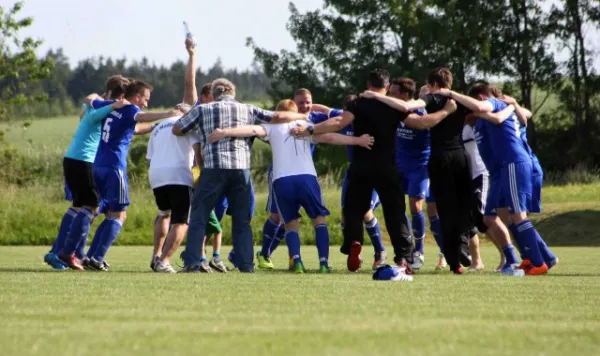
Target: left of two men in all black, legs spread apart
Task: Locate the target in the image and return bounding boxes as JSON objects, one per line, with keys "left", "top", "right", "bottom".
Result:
{"left": 291, "top": 70, "right": 454, "bottom": 281}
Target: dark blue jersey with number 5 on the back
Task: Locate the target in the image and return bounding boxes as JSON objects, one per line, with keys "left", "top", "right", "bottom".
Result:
{"left": 92, "top": 100, "right": 141, "bottom": 170}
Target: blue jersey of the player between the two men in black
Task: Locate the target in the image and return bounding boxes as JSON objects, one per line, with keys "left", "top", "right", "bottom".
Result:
{"left": 396, "top": 109, "right": 431, "bottom": 172}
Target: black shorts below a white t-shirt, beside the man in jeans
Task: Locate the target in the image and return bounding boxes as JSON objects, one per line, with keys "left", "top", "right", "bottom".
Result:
{"left": 152, "top": 185, "right": 192, "bottom": 224}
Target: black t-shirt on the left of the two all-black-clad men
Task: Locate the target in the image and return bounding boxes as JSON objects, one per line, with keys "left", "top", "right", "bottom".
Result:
{"left": 346, "top": 98, "right": 408, "bottom": 166}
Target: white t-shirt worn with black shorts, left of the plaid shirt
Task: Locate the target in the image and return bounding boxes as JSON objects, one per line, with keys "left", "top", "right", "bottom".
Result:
{"left": 146, "top": 117, "right": 199, "bottom": 189}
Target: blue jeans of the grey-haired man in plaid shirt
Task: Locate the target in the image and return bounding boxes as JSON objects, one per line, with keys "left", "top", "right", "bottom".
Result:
{"left": 185, "top": 168, "right": 254, "bottom": 272}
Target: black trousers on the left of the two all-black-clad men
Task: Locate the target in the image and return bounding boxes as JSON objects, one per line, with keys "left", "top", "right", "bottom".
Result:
{"left": 340, "top": 163, "right": 412, "bottom": 262}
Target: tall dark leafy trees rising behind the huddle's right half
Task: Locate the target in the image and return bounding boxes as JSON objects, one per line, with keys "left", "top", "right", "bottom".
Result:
{"left": 247, "top": 0, "right": 600, "bottom": 170}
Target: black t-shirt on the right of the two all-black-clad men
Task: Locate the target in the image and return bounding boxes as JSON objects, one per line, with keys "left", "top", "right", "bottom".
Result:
{"left": 421, "top": 94, "right": 470, "bottom": 154}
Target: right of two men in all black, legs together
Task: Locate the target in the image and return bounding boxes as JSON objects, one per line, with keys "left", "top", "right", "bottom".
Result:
{"left": 363, "top": 68, "right": 474, "bottom": 274}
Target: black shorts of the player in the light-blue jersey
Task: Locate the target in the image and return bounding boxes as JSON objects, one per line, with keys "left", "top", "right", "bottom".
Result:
{"left": 63, "top": 157, "right": 99, "bottom": 208}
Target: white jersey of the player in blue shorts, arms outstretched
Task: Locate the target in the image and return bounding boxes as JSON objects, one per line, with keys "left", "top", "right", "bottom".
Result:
{"left": 262, "top": 120, "right": 317, "bottom": 182}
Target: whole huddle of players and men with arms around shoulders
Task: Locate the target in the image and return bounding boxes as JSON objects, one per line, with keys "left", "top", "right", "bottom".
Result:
{"left": 44, "top": 40, "right": 558, "bottom": 281}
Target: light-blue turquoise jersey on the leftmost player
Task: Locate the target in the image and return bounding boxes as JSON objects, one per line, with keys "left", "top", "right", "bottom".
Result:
{"left": 65, "top": 105, "right": 112, "bottom": 163}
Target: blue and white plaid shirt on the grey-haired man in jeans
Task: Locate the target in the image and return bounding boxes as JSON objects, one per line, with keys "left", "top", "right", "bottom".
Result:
{"left": 175, "top": 96, "right": 275, "bottom": 169}
